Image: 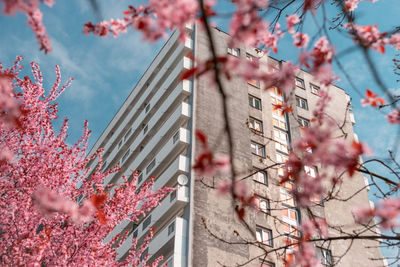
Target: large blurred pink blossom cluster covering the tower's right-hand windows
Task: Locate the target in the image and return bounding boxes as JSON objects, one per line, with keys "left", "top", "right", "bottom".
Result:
{"left": 281, "top": 91, "right": 369, "bottom": 207}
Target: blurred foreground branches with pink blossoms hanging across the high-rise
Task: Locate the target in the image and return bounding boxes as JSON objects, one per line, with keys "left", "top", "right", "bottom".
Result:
{"left": 0, "top": 0, "right": 400, "bottom": 266}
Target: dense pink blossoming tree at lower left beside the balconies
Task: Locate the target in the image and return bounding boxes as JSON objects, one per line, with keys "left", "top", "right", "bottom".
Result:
{"left": 0, "top": 57, "right": 172, "bottom": 266}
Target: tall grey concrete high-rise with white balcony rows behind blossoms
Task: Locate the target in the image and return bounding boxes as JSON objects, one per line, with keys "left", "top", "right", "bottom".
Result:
{"left": 86, "top": 27, "right": 382, "bottom": 267}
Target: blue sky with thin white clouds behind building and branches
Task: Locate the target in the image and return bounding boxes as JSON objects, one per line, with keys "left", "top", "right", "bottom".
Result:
{"left": 0, "top": 0, "right": 400, "bottom": 260}
